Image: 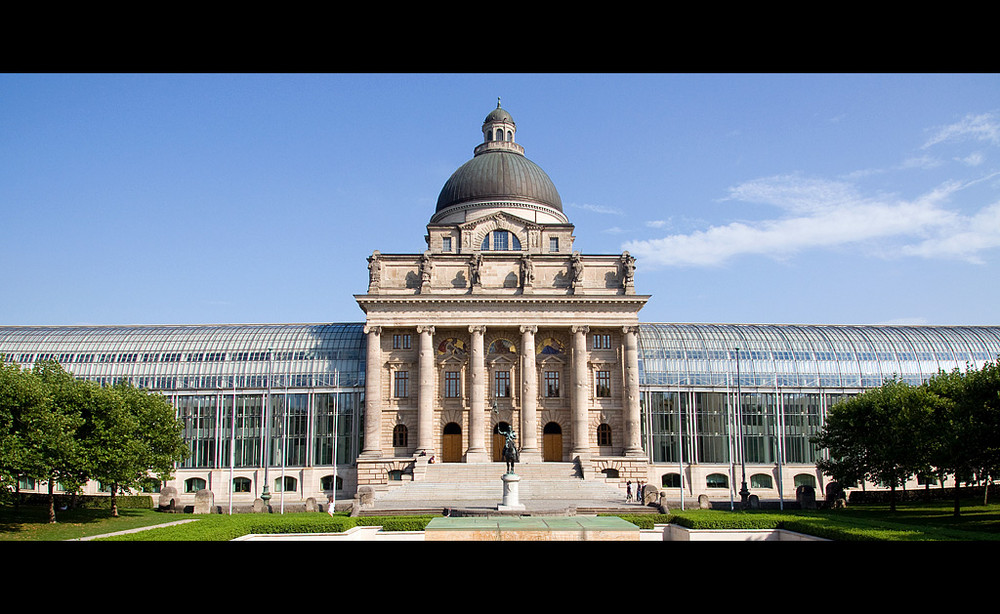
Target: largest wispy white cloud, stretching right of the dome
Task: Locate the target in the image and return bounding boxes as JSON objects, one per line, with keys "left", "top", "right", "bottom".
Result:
{"left": 622, "top": 176, "right": 1000, "bottom": 268}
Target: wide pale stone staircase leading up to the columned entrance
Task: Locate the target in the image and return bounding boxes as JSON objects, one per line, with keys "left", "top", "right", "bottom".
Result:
{"left": 363, "top": 462, "right": 656, "bottom": 515}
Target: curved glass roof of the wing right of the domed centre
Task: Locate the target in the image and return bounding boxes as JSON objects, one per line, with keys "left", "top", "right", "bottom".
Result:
{"left": 639, "top": 324, "right": 1000, "bottom": 388}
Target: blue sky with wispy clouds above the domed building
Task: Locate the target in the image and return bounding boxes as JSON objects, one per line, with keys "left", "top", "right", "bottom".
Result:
{"left": 0, "top": 74, "right": 1000, "bottom": 325}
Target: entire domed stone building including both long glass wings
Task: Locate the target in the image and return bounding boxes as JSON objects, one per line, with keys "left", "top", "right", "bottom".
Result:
{"left": 0, "top": 104, "right": 1000, "bottom": 505}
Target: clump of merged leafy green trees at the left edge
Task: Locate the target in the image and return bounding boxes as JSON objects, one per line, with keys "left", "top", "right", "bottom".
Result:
{"left": 0, "top": 362, "right": 186, "bottom": 522}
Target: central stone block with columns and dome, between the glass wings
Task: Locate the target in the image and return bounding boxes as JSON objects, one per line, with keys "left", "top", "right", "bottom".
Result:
{"left": 355, "top": 104, "right": 649, "bottom": 485}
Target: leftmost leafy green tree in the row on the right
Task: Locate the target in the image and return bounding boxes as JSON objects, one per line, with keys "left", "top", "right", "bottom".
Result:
{"left": 812, "top": 379, "right": 942, "bottom": 511}
